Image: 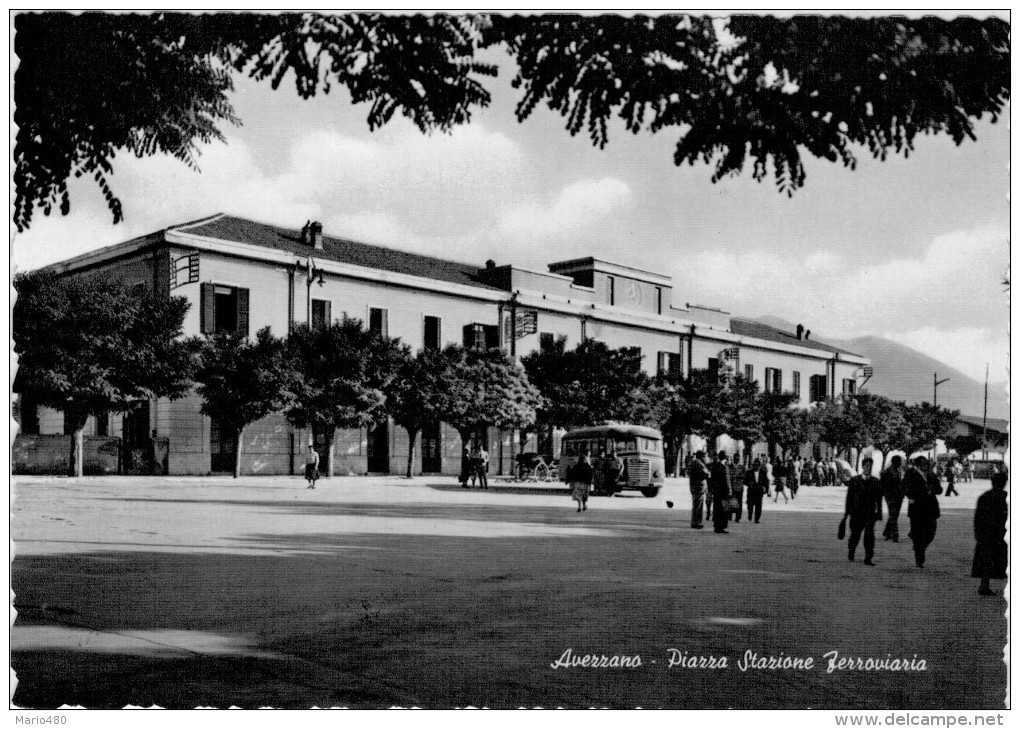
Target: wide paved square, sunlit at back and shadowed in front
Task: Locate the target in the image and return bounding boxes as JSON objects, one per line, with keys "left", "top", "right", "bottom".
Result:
{"left": 11, "top": 477, "right": 1007, "bottom": 710}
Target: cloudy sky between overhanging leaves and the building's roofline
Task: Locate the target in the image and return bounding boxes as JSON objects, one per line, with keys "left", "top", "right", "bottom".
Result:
{"left": 13, "top": 17, "right": 1009, "bottom": 381}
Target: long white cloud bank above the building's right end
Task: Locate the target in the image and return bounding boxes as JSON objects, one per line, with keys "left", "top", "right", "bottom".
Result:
{"left": 675, "top": 228, "right": 1009, "bottom": 336}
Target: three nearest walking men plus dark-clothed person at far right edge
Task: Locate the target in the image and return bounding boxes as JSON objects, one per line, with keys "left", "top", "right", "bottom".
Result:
{"left": 844, "top": 456, "right": 1009, "bottom": 595}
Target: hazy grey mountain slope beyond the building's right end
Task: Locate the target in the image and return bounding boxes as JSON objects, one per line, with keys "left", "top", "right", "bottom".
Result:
{"left": 757, "top": 316, "right": 1010, "bottom": 418}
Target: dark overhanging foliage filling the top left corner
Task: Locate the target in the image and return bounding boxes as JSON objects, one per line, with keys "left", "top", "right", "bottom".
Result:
{"left": 14, "top": 12, "right": 496, "bottom": 230}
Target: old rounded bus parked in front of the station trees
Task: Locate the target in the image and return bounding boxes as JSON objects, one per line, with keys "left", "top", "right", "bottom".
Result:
{"left": 559, "top": 424, "right": 666, "bottom": 499}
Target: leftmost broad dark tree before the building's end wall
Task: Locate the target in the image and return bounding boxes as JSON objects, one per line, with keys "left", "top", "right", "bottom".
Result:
{"left": 12, "top": 272, "right": 194, "bottom": 476}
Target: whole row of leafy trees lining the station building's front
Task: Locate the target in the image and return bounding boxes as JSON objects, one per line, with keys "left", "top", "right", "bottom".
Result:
{"left": 13, "top": 273, "right": 957, "bottom": 476}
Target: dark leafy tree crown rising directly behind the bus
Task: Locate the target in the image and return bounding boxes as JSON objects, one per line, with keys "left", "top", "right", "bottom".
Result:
{"left": 521, "top": 336, "right": 653, "bottom": 429}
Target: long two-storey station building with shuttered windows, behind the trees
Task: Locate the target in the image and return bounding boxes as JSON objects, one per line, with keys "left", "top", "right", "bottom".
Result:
{"left": 21, "top": 214, "right": 869, "bottom": 474}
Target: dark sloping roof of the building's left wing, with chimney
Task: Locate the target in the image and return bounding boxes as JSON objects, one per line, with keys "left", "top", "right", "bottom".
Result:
{"left": 168, "top": 214, "right": 505, "bottom": 289}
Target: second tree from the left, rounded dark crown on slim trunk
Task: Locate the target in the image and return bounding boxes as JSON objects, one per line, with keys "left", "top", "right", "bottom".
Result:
{"left": 195, "top": 326, "right": 294, "bottom": 478}
